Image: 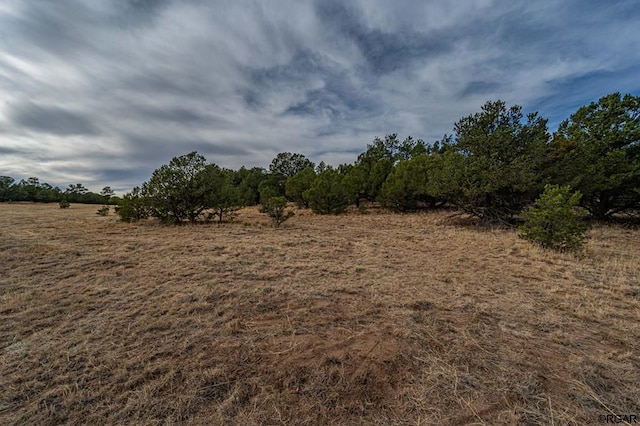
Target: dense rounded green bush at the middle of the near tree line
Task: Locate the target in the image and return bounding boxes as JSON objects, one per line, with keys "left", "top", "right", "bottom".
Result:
{"left": 304, "top": 167, "right": 350, "bottom": 214}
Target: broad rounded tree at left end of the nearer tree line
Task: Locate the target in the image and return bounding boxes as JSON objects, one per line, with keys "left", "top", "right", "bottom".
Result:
{"left": 142, "top": 151, "right": 206, "bottom": 223}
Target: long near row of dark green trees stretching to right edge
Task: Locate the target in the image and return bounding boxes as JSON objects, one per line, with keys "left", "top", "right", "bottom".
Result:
{"left": 119, "top": 93, "right": 640, "bottom": 224}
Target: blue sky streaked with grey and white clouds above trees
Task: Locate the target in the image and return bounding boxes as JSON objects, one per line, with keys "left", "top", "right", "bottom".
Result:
{"left": 0, "top": 0, "right": 640, "bottom": 192}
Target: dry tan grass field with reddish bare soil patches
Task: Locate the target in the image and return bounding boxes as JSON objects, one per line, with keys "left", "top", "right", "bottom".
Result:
{"left": 0, "top": 204, "right": 640, "bottom": 425}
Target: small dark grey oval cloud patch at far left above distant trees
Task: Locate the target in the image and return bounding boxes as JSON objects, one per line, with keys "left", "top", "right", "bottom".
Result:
{"left": 9, "top": 102, "right": 99, "bottom": 136}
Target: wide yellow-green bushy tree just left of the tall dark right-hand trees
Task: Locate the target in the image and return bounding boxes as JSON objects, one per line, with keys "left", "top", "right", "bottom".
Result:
{"left": 378, "top": 155, "right": 438, "bottom": 212}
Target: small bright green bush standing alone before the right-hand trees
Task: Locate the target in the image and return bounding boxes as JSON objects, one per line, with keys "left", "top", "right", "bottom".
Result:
{"left": 519, "top": 185, "right": 586, "bottom": 251}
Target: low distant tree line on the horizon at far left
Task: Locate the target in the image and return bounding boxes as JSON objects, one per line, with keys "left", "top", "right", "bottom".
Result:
{"left": 0, "top": 176, "right": 119, "bottom": 204}
